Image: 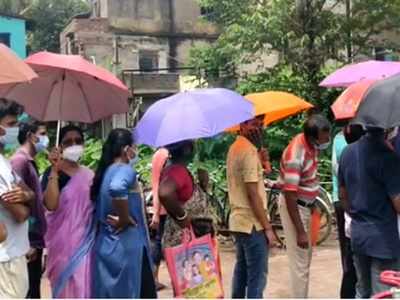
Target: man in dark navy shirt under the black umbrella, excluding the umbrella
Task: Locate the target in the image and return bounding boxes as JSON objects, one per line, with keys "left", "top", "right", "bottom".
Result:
{"left": 339, "top": 129, "right": 400, "bottom": 298}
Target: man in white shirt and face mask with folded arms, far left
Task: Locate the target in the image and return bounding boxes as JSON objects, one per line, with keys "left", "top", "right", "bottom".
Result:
{"left": 0, "top": 99, "right": 34, "bottom": 298}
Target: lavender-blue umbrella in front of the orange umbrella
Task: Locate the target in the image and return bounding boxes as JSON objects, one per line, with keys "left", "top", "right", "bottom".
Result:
{"left": 134, "top": 88, "right": 254, "bottom": 147}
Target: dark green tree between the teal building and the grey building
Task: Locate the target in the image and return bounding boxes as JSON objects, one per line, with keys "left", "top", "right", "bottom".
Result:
{"left": 25, "top": 0, "right": 89, "bottom": 52}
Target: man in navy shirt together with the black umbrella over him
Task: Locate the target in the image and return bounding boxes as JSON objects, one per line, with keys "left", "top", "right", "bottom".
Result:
{"left": 339, "top": 75, "right": 400, "bottom": 298}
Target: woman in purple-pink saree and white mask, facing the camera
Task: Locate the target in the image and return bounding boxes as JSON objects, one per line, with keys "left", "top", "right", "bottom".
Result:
{"left": 42, "top": 126, "right": 95, "bottom": 298}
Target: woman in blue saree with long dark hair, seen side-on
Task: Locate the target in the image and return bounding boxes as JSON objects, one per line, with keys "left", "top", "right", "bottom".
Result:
{"left": 92, "top": 129, "right": 157, "bottom": 298}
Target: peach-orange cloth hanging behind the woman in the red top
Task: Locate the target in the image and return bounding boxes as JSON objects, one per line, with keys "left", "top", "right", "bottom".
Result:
{"left": 151, "top": 148, "right": 169, "bottom": 216}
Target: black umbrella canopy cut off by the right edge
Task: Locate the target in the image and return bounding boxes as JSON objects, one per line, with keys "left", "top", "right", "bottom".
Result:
{"left": 354, "top": 75, "right": 400, "bottom": 129}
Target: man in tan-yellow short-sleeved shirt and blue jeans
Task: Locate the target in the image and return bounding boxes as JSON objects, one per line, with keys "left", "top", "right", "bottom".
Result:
{"left": 227, "top": 116, "right": 274, "bottom": 298}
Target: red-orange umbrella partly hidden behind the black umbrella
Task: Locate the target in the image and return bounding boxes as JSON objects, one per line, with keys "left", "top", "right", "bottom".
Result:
{"left": 331, "top": 80, "right": 376, "bottom": 120}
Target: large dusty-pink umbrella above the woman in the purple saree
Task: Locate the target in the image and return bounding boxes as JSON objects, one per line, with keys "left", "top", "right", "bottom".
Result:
{"left": 0, "top": 52, "right": 129, "bottom": 123}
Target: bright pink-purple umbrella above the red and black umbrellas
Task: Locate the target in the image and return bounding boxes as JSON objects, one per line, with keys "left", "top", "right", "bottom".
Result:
{"left": 320, "top": 60, "right": 400, "bottom": 88}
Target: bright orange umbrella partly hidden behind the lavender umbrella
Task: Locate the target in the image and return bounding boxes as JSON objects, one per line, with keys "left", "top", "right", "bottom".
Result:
{"left": 228, "top": 91, "right": 313, "bottom": 131}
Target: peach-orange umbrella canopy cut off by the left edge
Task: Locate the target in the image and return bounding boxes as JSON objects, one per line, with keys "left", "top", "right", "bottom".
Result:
{"left": 0, "top": 43, "right": 37, "bottom": 85}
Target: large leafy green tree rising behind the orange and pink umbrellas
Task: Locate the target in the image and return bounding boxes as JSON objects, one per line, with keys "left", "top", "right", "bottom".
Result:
{"left": 190, "top": 0, "right": 400, "bottom": 107}
